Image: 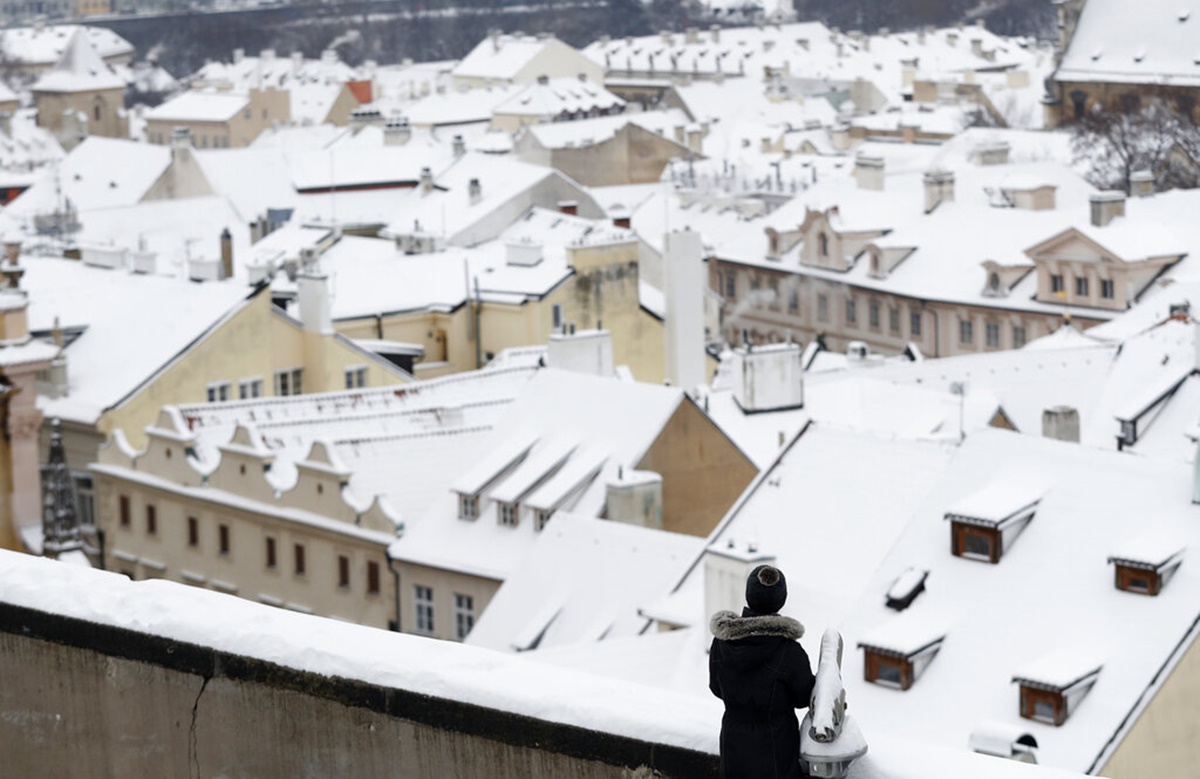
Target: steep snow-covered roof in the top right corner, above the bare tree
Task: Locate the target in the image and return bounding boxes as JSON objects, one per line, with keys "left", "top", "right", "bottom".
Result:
{"left": 1055, "top": 0, "right": 1200, "bottom": 86}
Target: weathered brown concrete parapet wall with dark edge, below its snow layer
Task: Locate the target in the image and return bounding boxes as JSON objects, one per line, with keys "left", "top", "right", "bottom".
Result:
{"left": 0, "top": 603, "right": 718, "bottom": 779}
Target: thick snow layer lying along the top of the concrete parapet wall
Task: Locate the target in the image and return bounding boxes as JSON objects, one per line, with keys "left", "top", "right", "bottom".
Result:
{"left": 0, "top": 551, "right": 1094, "bottom": 779}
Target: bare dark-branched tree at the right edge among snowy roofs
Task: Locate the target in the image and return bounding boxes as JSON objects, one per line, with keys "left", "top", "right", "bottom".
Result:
{"left": 1072, "top": 97, "right": 1200, "bottom": 192}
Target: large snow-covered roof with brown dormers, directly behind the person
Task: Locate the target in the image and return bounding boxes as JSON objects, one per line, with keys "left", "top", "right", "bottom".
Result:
{"left": 566, "top": 424, "right": 1200, "bottom": 771}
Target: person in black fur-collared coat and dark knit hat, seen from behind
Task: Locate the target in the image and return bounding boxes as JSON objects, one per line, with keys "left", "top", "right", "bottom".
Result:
{"left": 708, "top": 565, "right": 816, "bottom": 779}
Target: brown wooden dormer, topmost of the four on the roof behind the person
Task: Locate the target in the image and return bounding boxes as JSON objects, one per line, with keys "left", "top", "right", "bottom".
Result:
{"left": 946, "top": 477, "right": 1045, "bottom": 563}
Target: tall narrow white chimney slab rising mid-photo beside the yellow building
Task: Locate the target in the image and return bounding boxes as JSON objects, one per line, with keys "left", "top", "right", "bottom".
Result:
{"left": 662, "top": 230, "right": 707, "bottom": 391}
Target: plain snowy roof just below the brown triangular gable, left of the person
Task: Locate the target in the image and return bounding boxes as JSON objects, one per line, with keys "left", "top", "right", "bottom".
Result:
{"left": 467, "top": 511, "right": 703, "bottom": 652}
